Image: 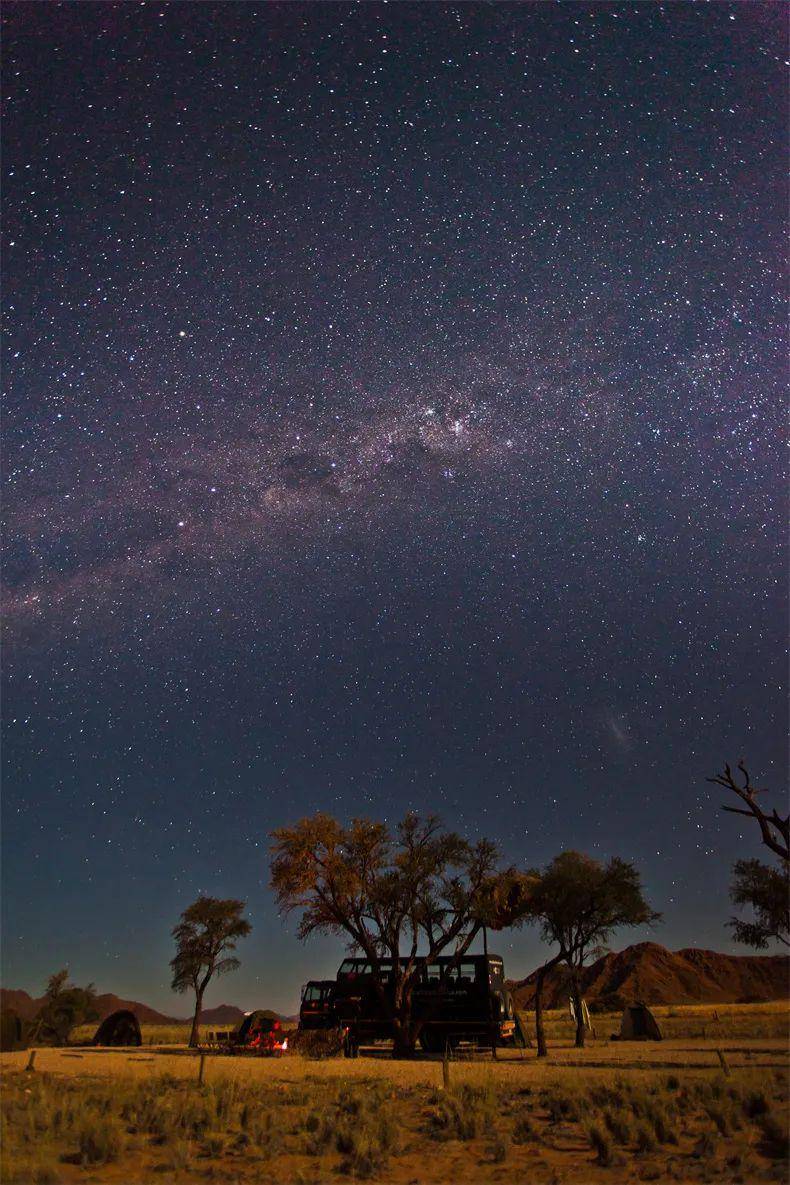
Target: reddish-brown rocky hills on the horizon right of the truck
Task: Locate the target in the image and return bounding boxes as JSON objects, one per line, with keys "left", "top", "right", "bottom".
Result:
{"left": 509, "top": 942, "right": 790, "bottom": 1008}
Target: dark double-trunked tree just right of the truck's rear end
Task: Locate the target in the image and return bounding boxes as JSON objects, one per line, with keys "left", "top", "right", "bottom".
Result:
{"left": 527, "top": 852, "right": 661, "bottom": 1057}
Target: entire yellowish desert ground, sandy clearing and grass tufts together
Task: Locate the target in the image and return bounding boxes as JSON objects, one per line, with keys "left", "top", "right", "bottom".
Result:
{"left": 0, "top": 1004, "right": 789, "bottom": 1185}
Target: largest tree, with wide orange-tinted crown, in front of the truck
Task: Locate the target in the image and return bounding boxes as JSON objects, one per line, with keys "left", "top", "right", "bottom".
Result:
{"left": 270, "top": 813, "right": 518, "bottom": 1057}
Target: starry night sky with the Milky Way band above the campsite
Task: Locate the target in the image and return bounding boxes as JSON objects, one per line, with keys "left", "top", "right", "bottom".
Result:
{"left": 2, "top": 2, "right": 786, "bottom": 1012}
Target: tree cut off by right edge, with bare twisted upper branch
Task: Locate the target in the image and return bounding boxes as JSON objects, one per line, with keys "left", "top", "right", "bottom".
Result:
{"left": 707, "top": 761, "right": 790, "bottom": 950}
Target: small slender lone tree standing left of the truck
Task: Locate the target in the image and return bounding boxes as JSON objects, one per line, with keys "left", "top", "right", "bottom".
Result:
{"left": 171, "top": 896, "right": 252, "bottom": 1048}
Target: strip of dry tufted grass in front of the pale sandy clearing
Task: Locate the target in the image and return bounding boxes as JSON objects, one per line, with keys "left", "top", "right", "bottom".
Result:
{"left": 2, "top": 1062, "right": 788, "bottom": 1185}
